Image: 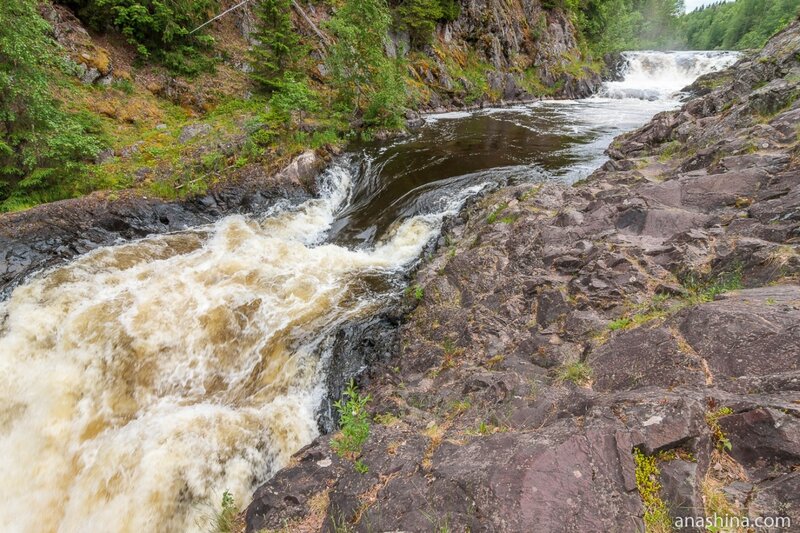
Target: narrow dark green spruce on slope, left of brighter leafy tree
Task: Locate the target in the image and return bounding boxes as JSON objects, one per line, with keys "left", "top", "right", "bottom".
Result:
{"left": 251, "top": 0, "right": 302, "bottom": 92}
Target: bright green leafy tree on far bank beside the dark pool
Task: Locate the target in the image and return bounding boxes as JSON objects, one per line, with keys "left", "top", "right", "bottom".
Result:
{"left": 326, "top": 0, "right": 407, "bottom": 128}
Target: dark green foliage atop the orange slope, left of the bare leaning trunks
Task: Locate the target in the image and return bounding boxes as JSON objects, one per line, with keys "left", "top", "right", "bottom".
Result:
{"left": 57, "top": 0, "right": 219, "bottom": 71}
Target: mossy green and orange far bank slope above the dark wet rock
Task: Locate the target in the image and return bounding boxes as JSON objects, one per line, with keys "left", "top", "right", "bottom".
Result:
{"left": 0, "top": 0, "right": 601, "bottom": 212}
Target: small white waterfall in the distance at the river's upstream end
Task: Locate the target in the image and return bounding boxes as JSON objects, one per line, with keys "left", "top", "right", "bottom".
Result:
{"left": 599, "top": 51, "right": 739, "bottom": 100}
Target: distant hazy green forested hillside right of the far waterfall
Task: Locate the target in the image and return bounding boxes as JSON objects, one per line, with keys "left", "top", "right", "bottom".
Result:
{"left": 681, "top": 0, "right": 800, "bottom": 50}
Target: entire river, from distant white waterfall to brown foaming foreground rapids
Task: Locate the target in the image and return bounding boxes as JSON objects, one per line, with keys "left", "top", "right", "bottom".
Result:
{"left": 0, "top": 52, "right": 736, "bottom": 532}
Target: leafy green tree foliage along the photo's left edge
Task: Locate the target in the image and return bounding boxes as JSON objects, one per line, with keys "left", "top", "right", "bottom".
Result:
{"left": 0, "top": 0, "right": 103, "bottom": 211}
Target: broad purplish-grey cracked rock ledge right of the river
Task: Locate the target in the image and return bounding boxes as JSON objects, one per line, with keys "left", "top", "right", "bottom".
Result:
{"left": 246, "top": 18, "right": 800, "bottom": 532}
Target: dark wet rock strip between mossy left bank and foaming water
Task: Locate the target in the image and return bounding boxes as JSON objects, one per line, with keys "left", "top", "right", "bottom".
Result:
{"left": 0, "top": 150, "right": 332, "bottom": 298}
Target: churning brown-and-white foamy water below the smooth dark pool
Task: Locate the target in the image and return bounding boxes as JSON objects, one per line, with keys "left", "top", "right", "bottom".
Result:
{"left": 0, "top": 163, "right": 488, "bottom": 532}
